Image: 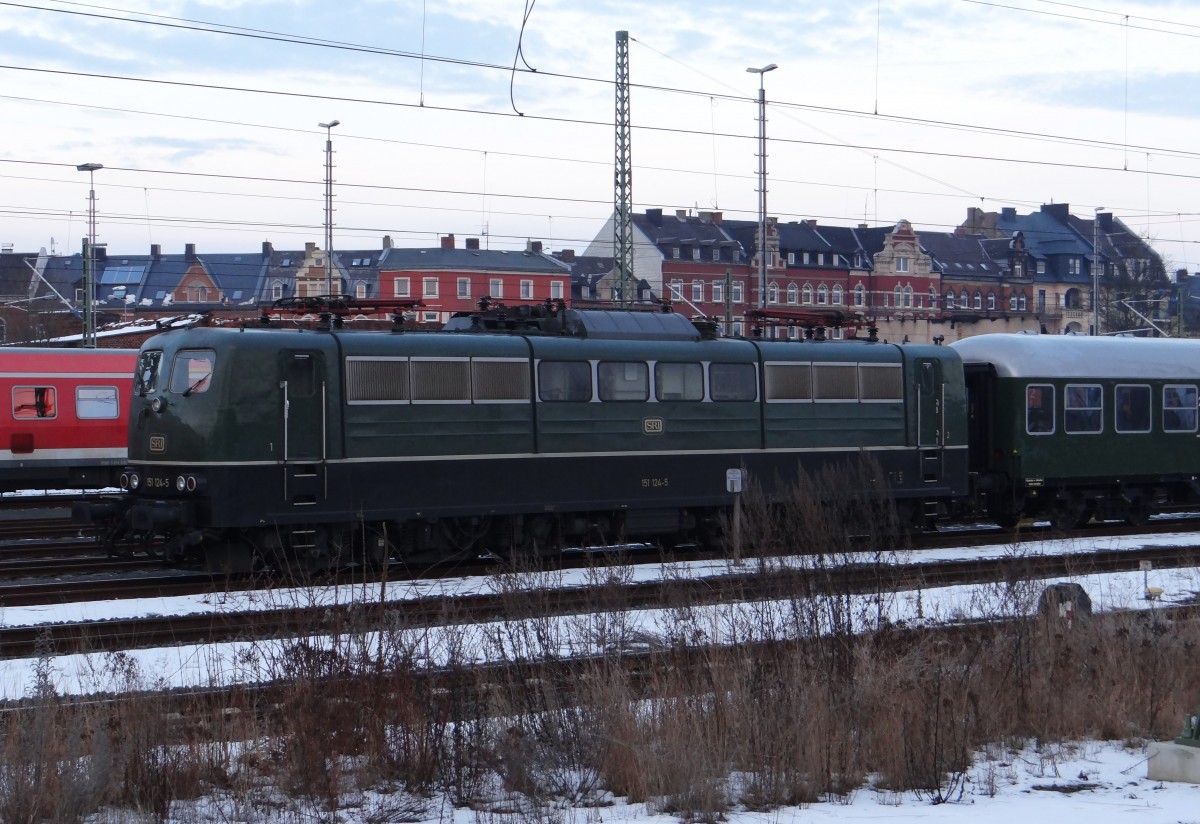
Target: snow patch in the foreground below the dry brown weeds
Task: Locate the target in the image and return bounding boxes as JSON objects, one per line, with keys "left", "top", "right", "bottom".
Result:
{"left": 154, "top": 741, "right": 1200, "bottom": 824}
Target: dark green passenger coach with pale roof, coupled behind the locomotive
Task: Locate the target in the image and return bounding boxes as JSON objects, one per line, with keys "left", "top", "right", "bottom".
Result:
{"left": 952, "top": 335, "right": 1200, "bottom": 528}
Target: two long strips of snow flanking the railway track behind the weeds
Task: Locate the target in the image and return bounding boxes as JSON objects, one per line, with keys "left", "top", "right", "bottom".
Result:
{"left": 0, "top": 533, "right": 1200, "bottom": 700}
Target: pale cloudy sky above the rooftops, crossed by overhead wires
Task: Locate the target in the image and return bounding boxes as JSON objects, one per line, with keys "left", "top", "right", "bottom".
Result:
{"left": 0, "top": 0, "right": 1200, "bottom": 270}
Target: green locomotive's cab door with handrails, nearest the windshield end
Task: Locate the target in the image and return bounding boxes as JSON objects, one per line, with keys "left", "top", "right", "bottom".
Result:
{"left": 280, "top": 351, "right": 328, "bottom": 506}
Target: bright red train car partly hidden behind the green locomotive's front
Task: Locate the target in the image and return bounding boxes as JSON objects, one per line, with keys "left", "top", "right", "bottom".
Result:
{"left": 0, "top": 348, "right": 138, "bottom": 492}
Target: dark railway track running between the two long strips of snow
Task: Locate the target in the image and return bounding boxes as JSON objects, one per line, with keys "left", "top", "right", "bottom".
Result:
{"left": 0, "top": 546, "right": 1200, "bottom": 657}
